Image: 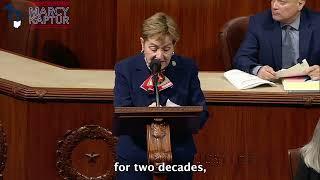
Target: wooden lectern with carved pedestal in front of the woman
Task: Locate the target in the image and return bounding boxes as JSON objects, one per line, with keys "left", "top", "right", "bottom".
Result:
{"left": 114, "top": 106, "right": 203, "bottom": 179}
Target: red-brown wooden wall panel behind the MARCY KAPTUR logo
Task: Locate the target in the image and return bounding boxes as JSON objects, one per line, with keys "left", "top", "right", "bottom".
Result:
{"left": 0, "top": 0, "right": 116, "bottom": 69}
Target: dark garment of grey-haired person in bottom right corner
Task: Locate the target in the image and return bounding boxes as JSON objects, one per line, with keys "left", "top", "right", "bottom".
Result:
{"left": 294, "top": 157, "right": 320, "bottom": 180}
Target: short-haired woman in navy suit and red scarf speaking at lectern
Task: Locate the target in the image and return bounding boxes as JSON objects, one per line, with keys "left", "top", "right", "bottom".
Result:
{"left": 114, "top": 13, "right": 208, "bottom": 180}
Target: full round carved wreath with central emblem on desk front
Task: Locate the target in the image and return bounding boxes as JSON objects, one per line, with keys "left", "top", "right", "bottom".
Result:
{"left": 56, "top": 125, "right": 117, "bottom": 180}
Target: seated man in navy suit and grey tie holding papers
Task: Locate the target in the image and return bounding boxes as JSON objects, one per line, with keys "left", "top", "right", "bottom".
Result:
{"left": 234, "top": 0, "right": 320, "bottom": 80}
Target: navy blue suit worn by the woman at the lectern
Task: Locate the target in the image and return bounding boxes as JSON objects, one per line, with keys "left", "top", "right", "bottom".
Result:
{"left": 114, "top": 54, "right": 208, "bottom": 163}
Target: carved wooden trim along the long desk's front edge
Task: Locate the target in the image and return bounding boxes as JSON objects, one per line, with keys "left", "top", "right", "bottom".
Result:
{"left": 0, "top": 72, "right": 320, "bottom": 106}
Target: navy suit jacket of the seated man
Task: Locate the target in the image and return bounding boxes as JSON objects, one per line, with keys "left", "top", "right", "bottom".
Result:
{"left": 233, "top": 8, "right": 320, "bottom": 73}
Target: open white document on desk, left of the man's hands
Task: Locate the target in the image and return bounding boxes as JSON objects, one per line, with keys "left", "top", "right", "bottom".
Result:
{"left": 224, "top": 69, "right": 276, "bottom": 89}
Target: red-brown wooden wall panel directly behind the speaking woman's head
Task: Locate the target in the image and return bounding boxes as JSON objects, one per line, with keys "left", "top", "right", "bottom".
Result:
{"left": 117, "top": 0, "right": 268, "bottom": 70}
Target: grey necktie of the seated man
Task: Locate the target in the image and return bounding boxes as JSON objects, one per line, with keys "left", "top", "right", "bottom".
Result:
{"left": 282, "top": 25, "right": 296, "bottom": 69}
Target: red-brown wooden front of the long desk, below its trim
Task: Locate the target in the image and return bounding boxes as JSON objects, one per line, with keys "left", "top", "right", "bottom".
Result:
{"left": 0, "top": 92, "right": 320, "bottom": 180}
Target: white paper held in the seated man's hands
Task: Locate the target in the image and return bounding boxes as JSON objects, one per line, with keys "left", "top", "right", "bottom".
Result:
{"left": 276, "top": 59, "right": 309, "bottom": 78}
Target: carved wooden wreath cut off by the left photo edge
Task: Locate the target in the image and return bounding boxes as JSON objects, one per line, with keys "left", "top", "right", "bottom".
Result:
{"left": 0, "top": 124, "right": 8, "bottom": 179}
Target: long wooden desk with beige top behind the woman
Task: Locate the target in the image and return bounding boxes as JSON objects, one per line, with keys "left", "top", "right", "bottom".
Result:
{"left": 0, "top": 51, "right": 320, "bottom": 180}
